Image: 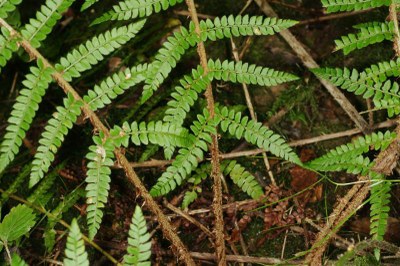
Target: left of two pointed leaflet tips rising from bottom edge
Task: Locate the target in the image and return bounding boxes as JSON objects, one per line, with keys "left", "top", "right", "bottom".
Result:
{"left": 64, "top": 219, "right": 89, "bottom": 266}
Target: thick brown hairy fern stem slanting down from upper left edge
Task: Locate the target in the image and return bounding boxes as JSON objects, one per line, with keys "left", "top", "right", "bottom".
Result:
{"left": 0, "top": 18, "right": 195, "bottom": 265}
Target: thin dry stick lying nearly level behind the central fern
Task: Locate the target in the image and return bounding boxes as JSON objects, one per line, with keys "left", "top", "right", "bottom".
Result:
{"left": 130, "top": 119, "right": 396, "bottom": 168}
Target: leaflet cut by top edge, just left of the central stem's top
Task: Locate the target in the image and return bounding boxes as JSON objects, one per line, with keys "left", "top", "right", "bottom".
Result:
{"left": 91, "top": 0, "right": 183, "bottom": 25}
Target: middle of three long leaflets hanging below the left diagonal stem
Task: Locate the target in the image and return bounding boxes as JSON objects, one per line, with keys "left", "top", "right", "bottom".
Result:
{"left": 29, "top": 94, "right": 82, "bottom": 187}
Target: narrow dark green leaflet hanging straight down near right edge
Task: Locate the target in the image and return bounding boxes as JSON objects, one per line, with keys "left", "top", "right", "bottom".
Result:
{"left": 370, "top": 173, "right": 391, "bottom": 243}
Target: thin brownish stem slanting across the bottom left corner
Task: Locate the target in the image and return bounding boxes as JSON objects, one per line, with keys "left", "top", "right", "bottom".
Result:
{"left": 0, "top": 188, "right": 121, "bottom": 265}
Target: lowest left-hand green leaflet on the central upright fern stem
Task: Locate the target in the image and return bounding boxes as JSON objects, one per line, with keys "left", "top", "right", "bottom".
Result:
{"left": 150, "top": 110, "right": 217, "bottom": 197}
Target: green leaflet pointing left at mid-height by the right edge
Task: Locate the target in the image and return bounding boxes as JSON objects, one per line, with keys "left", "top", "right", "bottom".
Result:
{"left": 307, "top": 131, "right": 396, "bottom": 174}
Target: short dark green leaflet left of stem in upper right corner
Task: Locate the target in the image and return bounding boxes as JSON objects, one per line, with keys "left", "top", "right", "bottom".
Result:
{"left": 335, "top": 22, "right": 393, "bottom": 55}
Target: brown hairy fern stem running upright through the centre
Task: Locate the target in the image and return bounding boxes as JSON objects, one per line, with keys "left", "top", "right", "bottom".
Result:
{"left": 186, "top": 0, "right": 226, "bottom": 265}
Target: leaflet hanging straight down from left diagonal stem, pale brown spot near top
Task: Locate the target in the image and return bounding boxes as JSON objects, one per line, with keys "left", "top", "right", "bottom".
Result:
{"left": 85, "top": 134, "right": 114, "bottom": 239}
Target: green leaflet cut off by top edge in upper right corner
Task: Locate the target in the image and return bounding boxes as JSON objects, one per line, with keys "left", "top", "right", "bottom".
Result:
{"left": 321, "top": 0, "right": 391, "bottom": 13}
